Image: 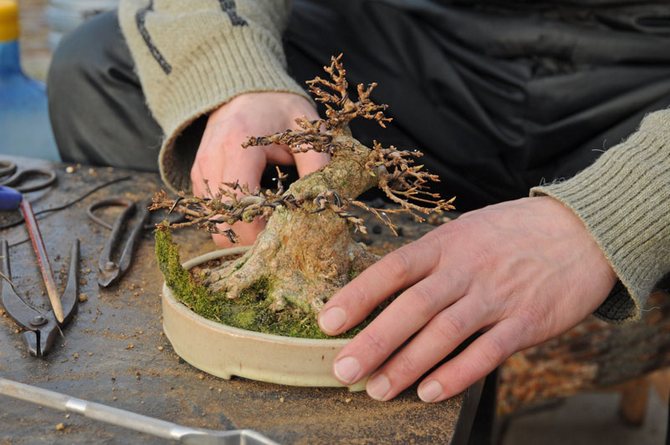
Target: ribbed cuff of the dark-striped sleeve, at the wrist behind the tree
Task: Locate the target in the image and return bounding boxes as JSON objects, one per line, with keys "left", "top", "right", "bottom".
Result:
{"left": 153, "top": 30, "right": 309, "bottom": 190}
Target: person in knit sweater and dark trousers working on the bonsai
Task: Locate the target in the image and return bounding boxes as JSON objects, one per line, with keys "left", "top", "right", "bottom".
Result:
{"left": 48, "top": 0, "right": 670, "bottom": 402}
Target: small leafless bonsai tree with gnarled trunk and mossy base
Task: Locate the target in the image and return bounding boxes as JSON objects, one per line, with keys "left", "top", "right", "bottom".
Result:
{"left": 152, "top": 55, "right": 453, "bottom": 336}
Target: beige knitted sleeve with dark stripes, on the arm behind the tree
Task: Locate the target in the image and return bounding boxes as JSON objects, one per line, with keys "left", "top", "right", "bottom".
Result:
{"left": 119, "top": 0, "right": 306, "bottom": 189}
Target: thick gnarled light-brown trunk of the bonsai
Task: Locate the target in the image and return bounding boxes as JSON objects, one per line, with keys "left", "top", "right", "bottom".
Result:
{"left": 205, "top": 135, "right": 377, "bottom": 313}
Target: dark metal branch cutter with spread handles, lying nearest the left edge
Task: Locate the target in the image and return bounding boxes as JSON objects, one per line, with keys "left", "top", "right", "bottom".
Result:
{"left": 0, "top": 240, "right": 79, "bottom": 357}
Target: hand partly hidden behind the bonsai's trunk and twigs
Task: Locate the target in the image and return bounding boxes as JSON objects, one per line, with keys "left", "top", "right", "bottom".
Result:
{"left": 191, "top": 92, "right": 329, "bottom": 247}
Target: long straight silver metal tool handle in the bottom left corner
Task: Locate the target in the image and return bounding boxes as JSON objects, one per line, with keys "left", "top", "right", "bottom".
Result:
{"left": 0, "top": 377, "right": 204, "bottom": 440}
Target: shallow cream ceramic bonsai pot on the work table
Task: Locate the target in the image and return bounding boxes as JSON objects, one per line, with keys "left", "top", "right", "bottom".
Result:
{"left": 162, "top": 248, "right": 365, "bottom": 391}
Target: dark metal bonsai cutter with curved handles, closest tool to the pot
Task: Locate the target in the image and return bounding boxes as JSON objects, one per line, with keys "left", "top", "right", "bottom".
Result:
{"left": 86, "top": 197, "right": 183, "bottom": 287}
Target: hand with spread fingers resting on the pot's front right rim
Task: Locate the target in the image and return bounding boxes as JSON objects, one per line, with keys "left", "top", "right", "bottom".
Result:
{"left": 319, "top": 197, "right": 616, "bottom": 402}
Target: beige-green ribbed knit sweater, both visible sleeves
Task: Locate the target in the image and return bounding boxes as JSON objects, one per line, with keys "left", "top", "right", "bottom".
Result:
{"left": 119, "top": 0, "right": 670, "bottom": 322}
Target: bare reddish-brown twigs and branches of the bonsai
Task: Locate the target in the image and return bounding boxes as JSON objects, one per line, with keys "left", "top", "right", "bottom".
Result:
{"left": 150, "top": 54, "right": 454, "bottom": 242}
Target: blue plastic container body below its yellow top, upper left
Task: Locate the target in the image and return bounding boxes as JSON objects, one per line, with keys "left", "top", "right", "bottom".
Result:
{"left": 0, "top": 40, "right": 60, "bottom": 161}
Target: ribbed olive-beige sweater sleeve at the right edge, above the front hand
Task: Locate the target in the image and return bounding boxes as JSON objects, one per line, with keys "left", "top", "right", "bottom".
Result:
{"left": 531, "top": 110, "right": 670, "bottom": 322}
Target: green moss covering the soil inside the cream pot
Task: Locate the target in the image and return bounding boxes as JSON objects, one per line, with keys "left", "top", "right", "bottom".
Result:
{"left": 155, "top": 225, "right": 381, "bottom": 338}
